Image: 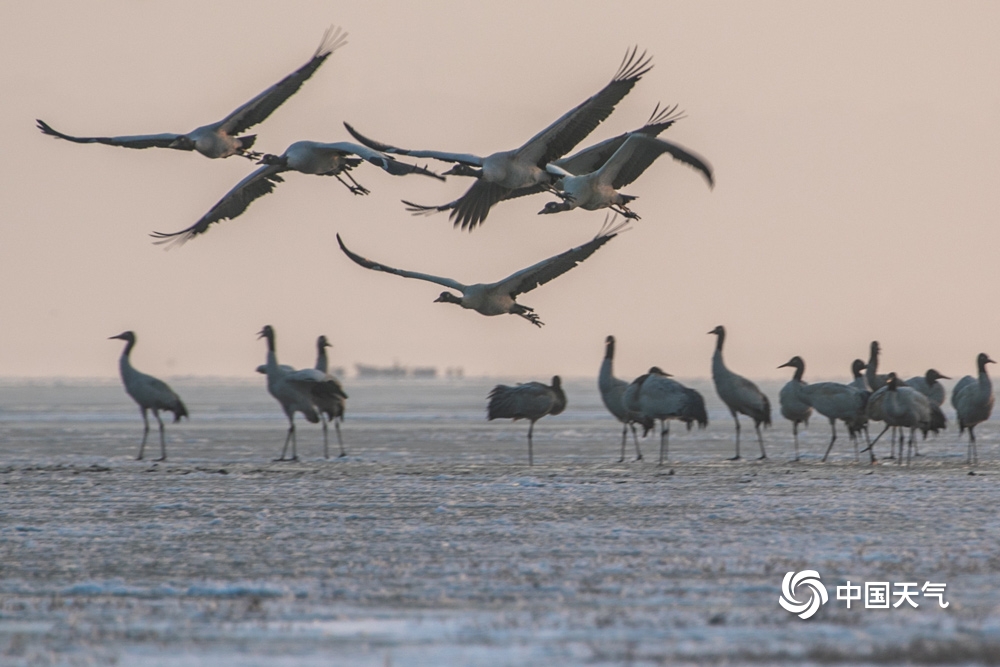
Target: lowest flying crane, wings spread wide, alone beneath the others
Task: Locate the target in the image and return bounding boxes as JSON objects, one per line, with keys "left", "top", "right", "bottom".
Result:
{"left": 337, "top": 222, "right": 627, "bottom": 327}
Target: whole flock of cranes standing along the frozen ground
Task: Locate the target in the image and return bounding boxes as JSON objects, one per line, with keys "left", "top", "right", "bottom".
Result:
{"left": 105, "top": 325, "right": 995, "bottom": 465}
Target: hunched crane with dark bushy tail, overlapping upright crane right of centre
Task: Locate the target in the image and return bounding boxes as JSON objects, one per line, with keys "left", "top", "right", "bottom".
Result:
{"left": 622, "top": 366, "right": 708, "bottom": 465}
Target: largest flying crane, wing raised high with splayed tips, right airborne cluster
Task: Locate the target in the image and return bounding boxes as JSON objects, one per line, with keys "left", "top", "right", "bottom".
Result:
{"left": 345, "top": 48, "right": 652, "bottom": 231}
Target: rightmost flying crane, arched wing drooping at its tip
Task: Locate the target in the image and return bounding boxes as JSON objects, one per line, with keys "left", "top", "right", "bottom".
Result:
{"left": 539, "top": 133, "right": 714, "bottom": 219}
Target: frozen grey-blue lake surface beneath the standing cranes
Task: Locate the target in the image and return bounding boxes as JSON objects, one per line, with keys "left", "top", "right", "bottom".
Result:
{"left": 0, "top": 378, "right": 1000, "bottom": 667}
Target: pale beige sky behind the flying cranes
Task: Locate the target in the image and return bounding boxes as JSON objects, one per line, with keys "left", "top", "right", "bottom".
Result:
{"left": 0, "top": 0, "right": 1000, "bottom": 379}
